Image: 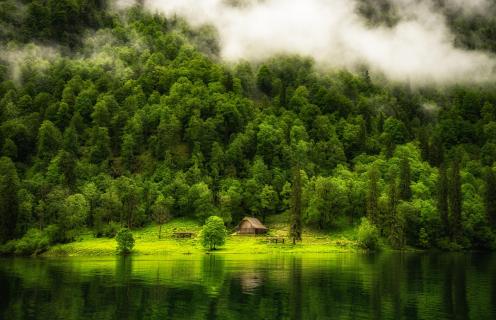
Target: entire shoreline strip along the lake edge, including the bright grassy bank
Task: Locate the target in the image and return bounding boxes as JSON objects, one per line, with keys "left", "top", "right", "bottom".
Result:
{"left": 5, "top": 220, "right": 494, "bottom": 258}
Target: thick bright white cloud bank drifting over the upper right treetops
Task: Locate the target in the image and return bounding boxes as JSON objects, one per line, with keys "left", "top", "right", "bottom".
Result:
{"left": 120, "top": 0, "right": 496, "bottom": 84}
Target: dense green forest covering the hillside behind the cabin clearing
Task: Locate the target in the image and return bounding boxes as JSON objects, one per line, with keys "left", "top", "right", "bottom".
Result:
{"left": 0, "top": 0, "right": 496, "bottom": 252}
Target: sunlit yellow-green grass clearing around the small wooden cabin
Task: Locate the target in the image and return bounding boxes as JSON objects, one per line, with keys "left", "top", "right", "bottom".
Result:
{"left": 44, "top": 215, "right": 359, "bottom": 256}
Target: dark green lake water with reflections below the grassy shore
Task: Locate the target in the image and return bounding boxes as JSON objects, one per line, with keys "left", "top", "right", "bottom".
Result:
{"left": 0, "top": 254, "right": 496, "bottom": 320}
